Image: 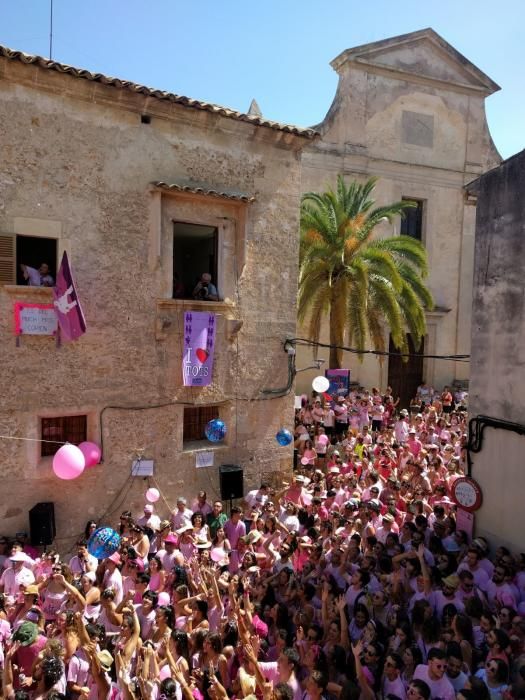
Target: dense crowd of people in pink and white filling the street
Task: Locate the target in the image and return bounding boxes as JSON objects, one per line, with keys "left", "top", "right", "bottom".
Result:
{"left": 0, "top": 384, "right": 525, "bottom": 700}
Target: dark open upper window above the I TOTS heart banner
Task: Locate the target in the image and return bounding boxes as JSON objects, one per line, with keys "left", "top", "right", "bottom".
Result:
{"left": 173, "top": 222, "right": 220, "bottom": 299}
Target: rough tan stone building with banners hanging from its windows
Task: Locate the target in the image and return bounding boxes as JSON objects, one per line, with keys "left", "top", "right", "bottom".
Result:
{"left": 0, "top": 49, "right": 315, "bottom": 547}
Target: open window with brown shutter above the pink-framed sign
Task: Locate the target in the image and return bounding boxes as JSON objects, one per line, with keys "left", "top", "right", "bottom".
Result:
{"left": 0, "top": 233, "right": 58, "bottom": 285}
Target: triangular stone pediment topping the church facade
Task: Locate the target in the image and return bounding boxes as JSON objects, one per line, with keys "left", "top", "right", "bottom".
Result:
{"left": 331, "top": 29, "right": 500, "bottom": 95}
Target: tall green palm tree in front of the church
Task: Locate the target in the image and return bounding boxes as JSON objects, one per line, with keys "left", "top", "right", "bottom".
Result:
{"left": 298, "top": 175, "right": 433, "bottom": 368}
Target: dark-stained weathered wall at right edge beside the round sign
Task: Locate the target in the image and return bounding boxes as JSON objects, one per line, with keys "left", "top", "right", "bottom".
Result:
{"left": 469, "top": 151, "right": 525, "bottom": 551}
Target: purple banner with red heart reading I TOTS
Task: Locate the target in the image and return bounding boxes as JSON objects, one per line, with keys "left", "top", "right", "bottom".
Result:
{"left": 182, "top": 311, "right": 215, "bottom": 386}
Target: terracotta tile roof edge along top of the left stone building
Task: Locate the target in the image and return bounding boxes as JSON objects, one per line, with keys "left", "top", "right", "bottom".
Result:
{"left": 0, "top": 46, "right": 318, "bottom": 139}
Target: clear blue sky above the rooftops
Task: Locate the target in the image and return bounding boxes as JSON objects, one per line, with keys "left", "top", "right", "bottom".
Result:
{"left": 0, "top": 0, "right": 525, "bottom": 158}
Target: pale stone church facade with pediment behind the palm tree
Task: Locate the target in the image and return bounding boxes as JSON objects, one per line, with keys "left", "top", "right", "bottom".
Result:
{"left": 297, "top": 29, "right": 500, "bottom": 400}
